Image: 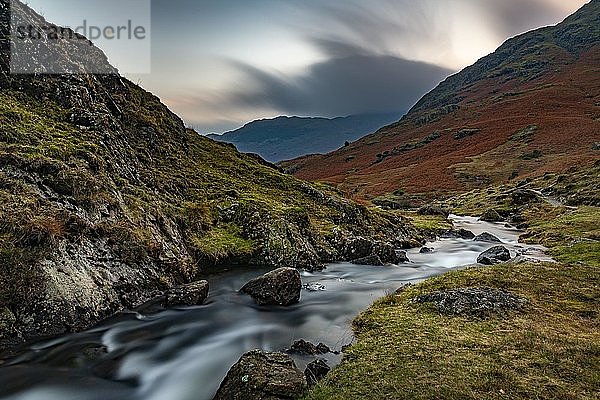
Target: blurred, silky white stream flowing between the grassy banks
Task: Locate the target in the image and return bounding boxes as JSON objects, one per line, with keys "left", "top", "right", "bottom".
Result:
{"left": 0, "top": 216, "right": 543, "bottom": 400}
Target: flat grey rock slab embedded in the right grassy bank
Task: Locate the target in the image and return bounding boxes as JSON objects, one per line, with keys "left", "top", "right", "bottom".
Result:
{"left": 413, "top": 287, "right": 527, "bottom": 318}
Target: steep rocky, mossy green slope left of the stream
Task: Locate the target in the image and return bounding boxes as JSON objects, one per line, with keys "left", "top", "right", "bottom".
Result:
{"left": 0, "top": 0, "right": 413, "bottom": 345}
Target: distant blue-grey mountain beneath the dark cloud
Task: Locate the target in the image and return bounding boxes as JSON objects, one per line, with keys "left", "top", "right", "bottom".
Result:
{"left": 207, "top": 113, "right": 402, "bottom": 162}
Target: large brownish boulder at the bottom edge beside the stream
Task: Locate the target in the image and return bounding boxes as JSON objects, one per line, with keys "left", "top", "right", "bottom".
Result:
{"left": 213, "top": 350, "right": 307, "bottom": 400}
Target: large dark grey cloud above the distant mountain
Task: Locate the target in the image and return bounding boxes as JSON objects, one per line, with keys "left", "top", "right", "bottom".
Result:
{"left": 230, "top": 49, "right": 452, "bottom": 116}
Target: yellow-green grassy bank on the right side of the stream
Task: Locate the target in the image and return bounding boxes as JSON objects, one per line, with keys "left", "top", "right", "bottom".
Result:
{"left": 306, "top": 174, "right": 600, "bottom": 400}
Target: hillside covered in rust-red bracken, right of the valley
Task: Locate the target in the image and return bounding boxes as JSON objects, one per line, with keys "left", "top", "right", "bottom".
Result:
{"left": 284, "top": 0, "right": 600, "bottom": 199}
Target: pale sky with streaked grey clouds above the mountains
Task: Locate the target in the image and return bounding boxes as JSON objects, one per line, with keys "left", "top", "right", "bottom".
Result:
{"left": 28, "top": 0, "right": 587, "bottom": 133}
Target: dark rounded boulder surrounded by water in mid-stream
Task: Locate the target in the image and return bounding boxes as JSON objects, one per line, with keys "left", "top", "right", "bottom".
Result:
{"left": 240, "top": 268, "right": 302, "bottom": 306}
